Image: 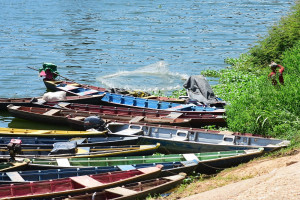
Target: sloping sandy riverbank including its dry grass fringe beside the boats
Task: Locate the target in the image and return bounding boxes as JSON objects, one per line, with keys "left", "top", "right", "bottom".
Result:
{"left": 159, "top": 148, "right": 300, "bottom": 200}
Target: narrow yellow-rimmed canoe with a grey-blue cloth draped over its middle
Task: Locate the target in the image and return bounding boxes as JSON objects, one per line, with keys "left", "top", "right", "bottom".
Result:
{"left": 0, "top": 142, "right": 160, "bottom": 159}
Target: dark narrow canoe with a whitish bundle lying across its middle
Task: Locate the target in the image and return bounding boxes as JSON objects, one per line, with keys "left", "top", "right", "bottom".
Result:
{"left": 0, "top": 94, "right": 104, "bottom": 111}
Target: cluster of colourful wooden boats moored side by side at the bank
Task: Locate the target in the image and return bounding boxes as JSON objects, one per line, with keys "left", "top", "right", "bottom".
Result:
{"left": 0, "top": 65, "right": 289, "bottom": 199}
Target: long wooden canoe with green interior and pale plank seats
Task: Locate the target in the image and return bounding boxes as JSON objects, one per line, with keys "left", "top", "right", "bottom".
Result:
{"left": 28, "top": 148, "right": 263, "bottom": 176}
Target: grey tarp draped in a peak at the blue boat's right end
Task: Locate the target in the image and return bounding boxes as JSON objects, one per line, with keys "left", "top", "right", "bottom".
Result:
{"left": 183, "top": 75, "right": 217, "bottom": 104}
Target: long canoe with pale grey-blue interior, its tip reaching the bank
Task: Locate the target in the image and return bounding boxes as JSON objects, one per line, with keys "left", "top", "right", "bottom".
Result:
{"left": 107, "top": 123, "right": 290, "bottom": 153}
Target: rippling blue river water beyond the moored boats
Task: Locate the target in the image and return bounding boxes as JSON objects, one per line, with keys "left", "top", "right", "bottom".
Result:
{"left": 0, "top": 0, "right": 293, "bottom": 128}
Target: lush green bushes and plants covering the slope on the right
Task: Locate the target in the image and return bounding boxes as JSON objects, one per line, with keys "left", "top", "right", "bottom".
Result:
{"left": 204, "top": 1, "right": 300, "bottom": 147}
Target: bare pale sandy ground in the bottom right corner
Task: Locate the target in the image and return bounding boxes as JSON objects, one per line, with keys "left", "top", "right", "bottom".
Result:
{"left": 180, "top": 150, "right": 300, "bottom": 200}
